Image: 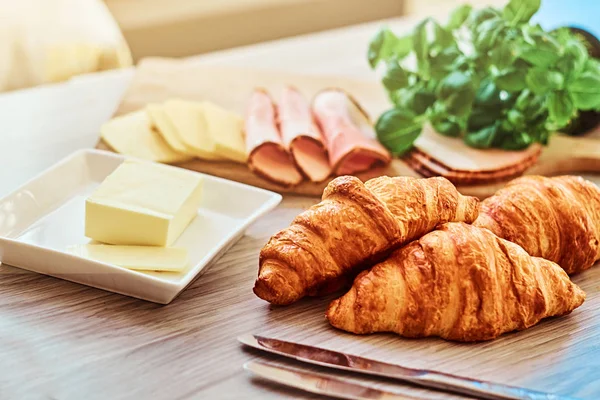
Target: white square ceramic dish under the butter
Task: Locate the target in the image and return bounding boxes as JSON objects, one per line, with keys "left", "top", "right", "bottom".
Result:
{"left": 0, "top": 150, "right": 281, "bottom": 304}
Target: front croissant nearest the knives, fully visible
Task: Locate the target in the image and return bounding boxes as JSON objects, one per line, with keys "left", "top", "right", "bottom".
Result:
{"left": 327, "top": 223, "right": 585, "bottom": 341}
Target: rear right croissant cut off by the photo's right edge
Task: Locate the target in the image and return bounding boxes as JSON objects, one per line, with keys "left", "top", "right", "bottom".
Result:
{"left": 474, "top": 176, "right": 600, "bottom": 274}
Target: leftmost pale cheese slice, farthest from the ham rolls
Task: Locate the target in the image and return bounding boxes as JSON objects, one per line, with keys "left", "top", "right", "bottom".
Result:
{"left": 100, "top": 110, "right": 190, "bottom": 163}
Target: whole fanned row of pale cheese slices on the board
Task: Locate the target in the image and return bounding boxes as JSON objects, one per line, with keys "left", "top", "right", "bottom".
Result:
{"left": 101, "top": 99, "right": 247, "bottom": 163}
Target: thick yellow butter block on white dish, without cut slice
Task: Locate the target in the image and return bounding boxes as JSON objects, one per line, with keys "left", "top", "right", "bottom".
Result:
{"left": 85, "top": 160, "right": 202, "bottom": 246}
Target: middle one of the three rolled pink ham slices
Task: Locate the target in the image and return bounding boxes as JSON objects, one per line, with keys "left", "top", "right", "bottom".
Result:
{"left": 278, "top": 86, "right": 331, "bottom": 182}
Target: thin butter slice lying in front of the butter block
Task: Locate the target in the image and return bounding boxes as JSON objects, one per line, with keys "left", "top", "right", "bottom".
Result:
{"left": 67, "top": 244, "right": 189, "bottom": 272}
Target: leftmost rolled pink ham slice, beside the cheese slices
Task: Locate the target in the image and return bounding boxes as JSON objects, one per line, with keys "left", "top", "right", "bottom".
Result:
{"left": 245, "top": 90, "right": 302, "bottom": 186}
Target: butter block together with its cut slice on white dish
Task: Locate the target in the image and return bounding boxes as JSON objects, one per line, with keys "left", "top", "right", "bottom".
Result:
{"left": 69, "top": 160, "right": 202, "bottom": 271}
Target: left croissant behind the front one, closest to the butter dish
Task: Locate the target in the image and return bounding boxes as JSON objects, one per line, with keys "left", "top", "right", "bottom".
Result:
{"left": 254, "top": 176, "right": 479, "bottom": 305}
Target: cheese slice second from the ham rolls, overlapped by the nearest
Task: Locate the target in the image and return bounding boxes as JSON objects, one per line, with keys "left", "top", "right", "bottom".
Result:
{"left": 163, "top": 99, "right": 221, "bottom": 160}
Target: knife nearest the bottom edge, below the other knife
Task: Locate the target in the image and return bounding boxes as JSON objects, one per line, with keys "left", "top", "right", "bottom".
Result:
{"left": 244, "top": 361, "right": 417, "bottom": 400}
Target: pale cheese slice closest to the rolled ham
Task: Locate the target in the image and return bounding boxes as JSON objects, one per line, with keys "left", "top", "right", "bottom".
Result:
{"left": 200, "top": 102, "right": 248, "bottom": 163}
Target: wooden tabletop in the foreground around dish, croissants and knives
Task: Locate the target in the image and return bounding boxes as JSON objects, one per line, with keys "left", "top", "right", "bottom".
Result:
{"left": 0, "top": 197, "right": 600, "bottom": 400}
